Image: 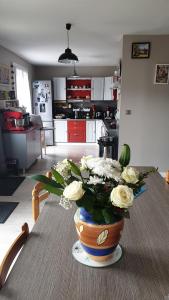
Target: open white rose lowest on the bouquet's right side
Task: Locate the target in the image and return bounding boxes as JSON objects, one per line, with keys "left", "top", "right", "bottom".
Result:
{"left": 110, "top": 185, "right": 134, "bottom": 208}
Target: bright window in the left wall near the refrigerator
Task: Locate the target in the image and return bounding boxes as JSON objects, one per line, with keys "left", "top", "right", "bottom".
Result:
{"left": 15, "top": 65, "right": 32, "bottom": 113}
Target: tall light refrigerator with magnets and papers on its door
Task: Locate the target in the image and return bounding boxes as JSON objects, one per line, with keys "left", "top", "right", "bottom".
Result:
{"left": 33, "top": 80, "right": 53, "bottom": 146}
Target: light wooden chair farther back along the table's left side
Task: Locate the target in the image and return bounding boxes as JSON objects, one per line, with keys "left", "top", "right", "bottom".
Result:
{"left": 32, "top": 172, "right": 52, "bottom": 222}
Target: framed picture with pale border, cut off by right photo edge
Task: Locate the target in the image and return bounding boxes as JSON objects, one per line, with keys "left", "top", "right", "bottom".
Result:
{"left": 154, "top": 64, "right": 169, "bottom": 84}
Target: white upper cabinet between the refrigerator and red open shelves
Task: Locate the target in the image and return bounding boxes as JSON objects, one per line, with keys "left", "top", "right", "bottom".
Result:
{"left": 53, "top": 77, "right": 66, "bottom": 100}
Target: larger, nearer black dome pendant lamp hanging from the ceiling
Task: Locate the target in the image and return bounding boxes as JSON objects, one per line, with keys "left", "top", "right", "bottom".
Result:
{"left": 58, "top": 23, "right": 79, "bottom": 64}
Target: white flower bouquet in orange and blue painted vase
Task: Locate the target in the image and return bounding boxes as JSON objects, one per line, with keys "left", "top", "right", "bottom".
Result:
{"left": 33, "top": 144, "right": 154, "bottom": 262}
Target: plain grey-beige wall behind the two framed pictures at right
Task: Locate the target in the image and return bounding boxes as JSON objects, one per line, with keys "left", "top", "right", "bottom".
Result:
{"left": 119, "top": 35, "right": 169, "bottom": 172}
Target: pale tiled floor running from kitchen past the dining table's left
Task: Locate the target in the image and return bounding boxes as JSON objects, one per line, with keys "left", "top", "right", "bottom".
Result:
{"left": 0, "top": 144, "right": 98, "bottom": 262}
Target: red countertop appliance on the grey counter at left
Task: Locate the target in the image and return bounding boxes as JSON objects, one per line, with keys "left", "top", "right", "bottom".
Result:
{"left": 3, "top": 111, "right": 29, "bottom": 131}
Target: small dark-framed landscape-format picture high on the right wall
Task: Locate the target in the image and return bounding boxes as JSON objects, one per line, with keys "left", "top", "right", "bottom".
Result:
{"left": 131, "top": 42, "right": 150, "bottom": 58}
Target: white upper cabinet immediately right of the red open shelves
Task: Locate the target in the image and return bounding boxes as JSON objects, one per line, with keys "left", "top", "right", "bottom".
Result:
{"left": 91, "top": 77, "right": 104, "bottom": 101}
